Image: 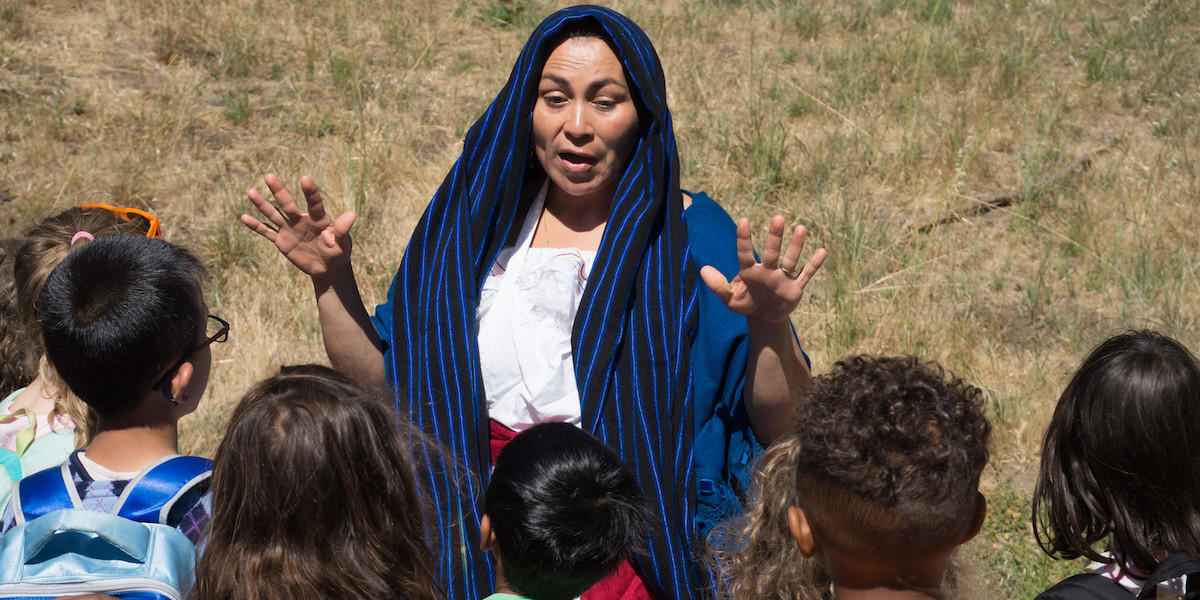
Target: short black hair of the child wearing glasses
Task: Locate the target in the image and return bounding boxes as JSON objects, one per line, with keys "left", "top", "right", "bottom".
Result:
{"left": 38, "top": 235, "right": 205, "bottom": 416}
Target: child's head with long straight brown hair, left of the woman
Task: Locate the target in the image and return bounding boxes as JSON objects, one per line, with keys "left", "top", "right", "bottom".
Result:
{"left": 192, "top": 365, "right": 437, "bottom": 600}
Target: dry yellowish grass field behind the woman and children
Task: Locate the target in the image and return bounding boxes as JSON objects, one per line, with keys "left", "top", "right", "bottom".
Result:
{"left": 0, "top": 0, "right": 1200, "bottom": 598}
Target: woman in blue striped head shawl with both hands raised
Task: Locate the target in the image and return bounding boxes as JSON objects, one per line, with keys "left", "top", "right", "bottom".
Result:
{"left": 241, "top": 6, "right": 826, "bottom": 600}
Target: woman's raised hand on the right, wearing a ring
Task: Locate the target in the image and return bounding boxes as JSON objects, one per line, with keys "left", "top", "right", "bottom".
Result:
{"left": 700, "top": 215, "right": 828, "bottom": 323}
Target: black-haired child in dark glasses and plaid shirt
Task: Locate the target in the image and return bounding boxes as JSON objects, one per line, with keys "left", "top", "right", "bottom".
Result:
{"left": 0, "top": 235, "right": 229, "bottom": 544}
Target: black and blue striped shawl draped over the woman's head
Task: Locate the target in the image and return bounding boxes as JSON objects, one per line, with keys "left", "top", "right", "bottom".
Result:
{"left": 389, "top": 6, "right": 712, "bottom": 600}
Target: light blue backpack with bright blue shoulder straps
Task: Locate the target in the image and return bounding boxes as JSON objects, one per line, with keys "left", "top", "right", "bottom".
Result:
{"left": 0, "top": 455, "right": 212, "bottom": 600}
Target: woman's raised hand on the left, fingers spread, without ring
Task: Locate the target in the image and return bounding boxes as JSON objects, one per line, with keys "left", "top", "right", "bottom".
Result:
{"left": 241, "top": 173, "right": 358, "bottom": 280}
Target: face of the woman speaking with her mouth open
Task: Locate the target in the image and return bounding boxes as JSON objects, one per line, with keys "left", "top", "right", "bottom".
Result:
{"left": 533, "top": 37, "right": 637, "bottom": 202}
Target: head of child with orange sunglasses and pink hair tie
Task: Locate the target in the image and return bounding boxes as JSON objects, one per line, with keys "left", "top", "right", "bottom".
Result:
{"left": 0, "top": 204, "right": 162, "bottom": 445}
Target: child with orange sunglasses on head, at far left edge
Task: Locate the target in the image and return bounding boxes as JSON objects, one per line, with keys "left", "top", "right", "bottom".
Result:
{"left": 0, "top": 204, "right": 162, "bottom": 505}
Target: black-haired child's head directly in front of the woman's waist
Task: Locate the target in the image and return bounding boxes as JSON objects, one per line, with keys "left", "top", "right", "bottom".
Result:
{"left": 481, "top": 422, "right": 646, "bottom": 600}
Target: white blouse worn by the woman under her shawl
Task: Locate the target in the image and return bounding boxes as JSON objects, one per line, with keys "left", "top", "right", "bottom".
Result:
{"left": 475, "top": 187, "right": 596, "bottom": 431}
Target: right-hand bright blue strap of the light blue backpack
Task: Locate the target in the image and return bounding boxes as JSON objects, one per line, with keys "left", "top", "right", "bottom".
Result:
{"left": 113, "top": 455, "right": 212, "bottom": 524}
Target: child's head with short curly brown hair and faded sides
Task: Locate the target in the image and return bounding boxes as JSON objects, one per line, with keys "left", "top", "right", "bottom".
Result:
{"left": 788, "top": 356, "right": 991, "bottom": 592}
